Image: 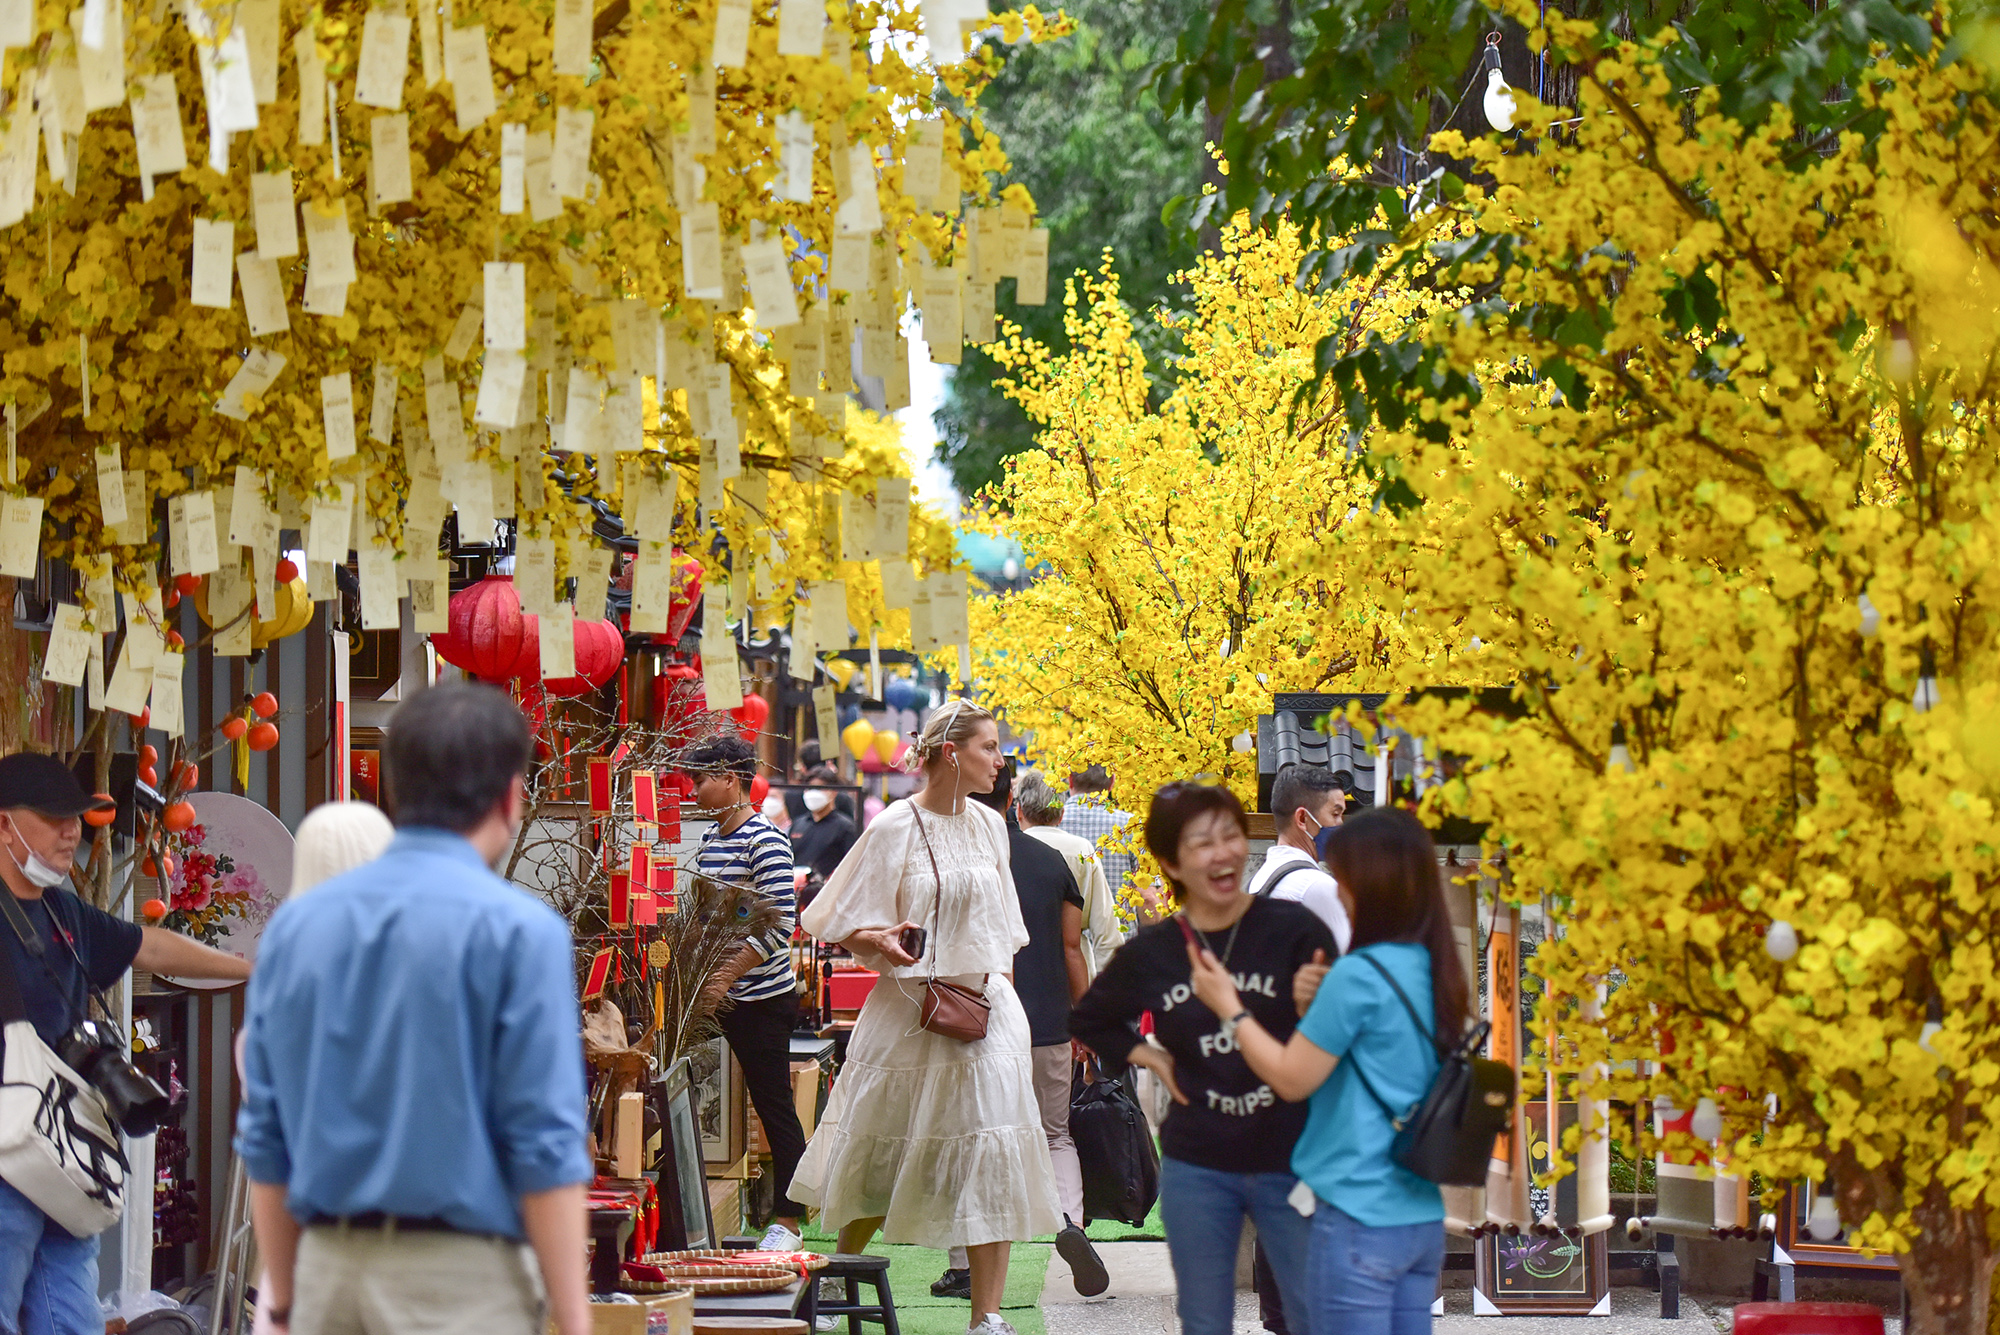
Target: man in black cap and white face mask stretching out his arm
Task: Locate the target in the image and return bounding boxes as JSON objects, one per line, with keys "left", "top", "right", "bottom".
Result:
{"left": 0, "top": 753, "right": 250, "bottom": 1335}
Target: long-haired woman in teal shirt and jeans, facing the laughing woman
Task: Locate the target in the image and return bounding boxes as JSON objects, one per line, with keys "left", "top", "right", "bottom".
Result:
{"left": 1188, "top": 807, "right": 1468, "bottom": 1335}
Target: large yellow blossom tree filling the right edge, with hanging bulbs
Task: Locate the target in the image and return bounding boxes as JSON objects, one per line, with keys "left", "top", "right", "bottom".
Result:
{"left": 1328, "top": 10, "right": 2000, "bottom": 1333}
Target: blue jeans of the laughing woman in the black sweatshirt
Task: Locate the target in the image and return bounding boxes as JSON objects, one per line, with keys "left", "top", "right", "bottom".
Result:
{"left": 1160, "top": 1155, "right": 1312, "bottom": 1335}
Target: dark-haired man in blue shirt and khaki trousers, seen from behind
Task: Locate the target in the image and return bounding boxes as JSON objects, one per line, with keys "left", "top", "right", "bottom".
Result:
{"left": 236, "top": 683, "right": 592, "bottom": 1335}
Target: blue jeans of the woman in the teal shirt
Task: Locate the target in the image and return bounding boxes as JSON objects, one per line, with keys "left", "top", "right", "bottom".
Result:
{"left": 1294, "top": 1201, "right": 1444, "bottom": 1335}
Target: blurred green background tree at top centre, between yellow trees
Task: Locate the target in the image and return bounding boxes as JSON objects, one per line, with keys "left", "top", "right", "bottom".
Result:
{"left": 936, "top": 0, "right": 1208, "bottom": 496}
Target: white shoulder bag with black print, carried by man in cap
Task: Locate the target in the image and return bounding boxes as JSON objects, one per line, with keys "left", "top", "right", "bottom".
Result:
{"left": 0, "top": 885, "right": 126, "bottom": 1237}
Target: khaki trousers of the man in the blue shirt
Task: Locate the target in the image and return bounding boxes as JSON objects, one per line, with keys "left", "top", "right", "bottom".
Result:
{"left": 292, "top": 1225, "right": 548, "bottom": 1335}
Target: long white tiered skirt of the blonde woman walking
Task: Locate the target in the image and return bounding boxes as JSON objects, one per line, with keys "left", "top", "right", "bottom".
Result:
{"left": 790, "top": 973, "right": 1062, "bottom": 1249}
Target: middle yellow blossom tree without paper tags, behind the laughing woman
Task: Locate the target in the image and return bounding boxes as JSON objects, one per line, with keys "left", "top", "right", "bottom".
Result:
{"left": 974, "top": 224, "right": 1462, "bottom": 887}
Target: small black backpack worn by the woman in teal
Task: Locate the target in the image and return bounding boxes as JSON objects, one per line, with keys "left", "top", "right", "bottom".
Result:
{"left": 1342, "top": 955, "right": 1514, "bottom": 1187}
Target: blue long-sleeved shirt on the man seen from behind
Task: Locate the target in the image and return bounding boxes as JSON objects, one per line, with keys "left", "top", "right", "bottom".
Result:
{"left": 236, "top": 829, "right": 592, "bottom": 1239}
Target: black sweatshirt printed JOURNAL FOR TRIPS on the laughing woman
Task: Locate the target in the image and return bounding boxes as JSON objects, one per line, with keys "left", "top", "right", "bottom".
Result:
{"left": 1070, "top": 897, "right": 1338, "bottom": 1173}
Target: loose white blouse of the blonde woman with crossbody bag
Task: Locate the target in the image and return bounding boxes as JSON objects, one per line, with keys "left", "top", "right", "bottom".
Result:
{"left": 798, "top": 799, "right": 1028, "bottom": 977}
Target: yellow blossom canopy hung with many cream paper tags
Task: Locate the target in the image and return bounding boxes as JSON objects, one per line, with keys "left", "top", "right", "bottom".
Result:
{"left": 0, "top": 0, "right": 1066, "bottom": 751}
